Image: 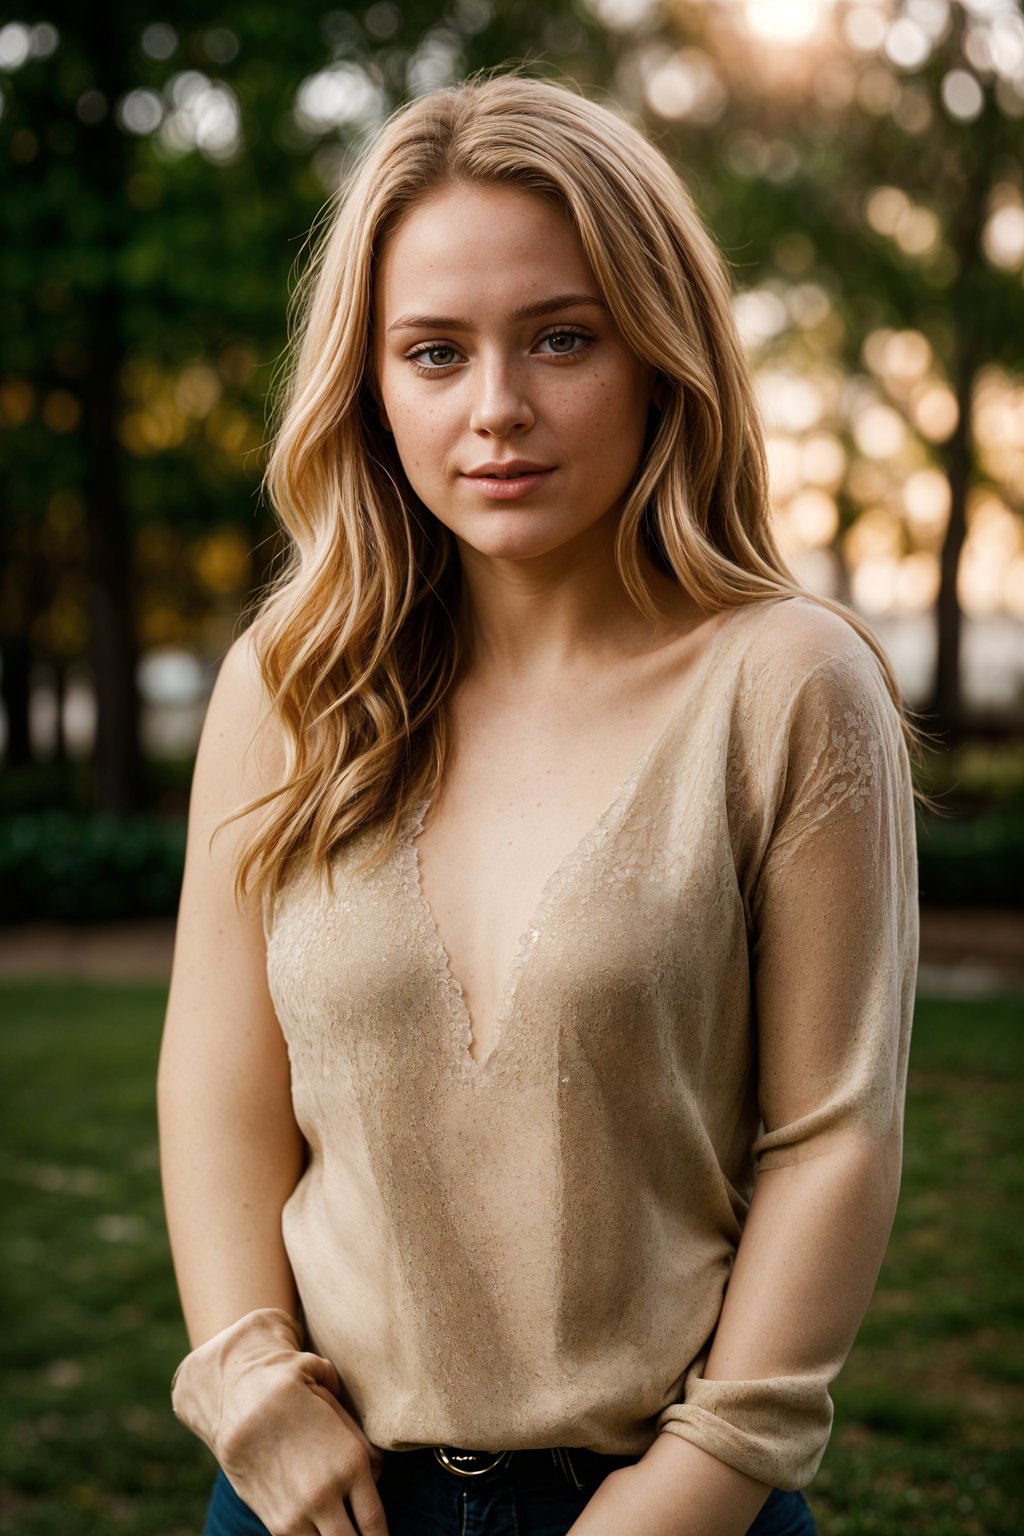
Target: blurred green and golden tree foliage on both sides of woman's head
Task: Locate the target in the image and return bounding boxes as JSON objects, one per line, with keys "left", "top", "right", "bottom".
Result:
{"left": 0, "top": 0, "right": 1024, "bottom": 813}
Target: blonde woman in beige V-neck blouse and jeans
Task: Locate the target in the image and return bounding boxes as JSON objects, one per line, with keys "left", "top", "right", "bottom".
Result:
{"left": 160, "top": 74, "right": 920, "bottom": 1536}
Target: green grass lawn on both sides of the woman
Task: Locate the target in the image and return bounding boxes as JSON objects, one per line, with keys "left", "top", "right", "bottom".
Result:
{"left": 0, "top": 982, "right": 1024, "bottom": 1536}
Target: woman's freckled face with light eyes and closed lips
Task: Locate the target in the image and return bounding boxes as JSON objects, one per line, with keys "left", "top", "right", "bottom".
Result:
{"left": 373, "top": 184, "right": 656, "bottom": 559}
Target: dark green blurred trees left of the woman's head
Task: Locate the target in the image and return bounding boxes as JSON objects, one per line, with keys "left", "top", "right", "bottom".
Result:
{"left": 0, "top": 0, "right": 608, "bottom": 813}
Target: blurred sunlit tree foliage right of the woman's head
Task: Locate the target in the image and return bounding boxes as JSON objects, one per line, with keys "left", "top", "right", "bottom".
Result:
{"left": 601, "top": 0, "right": 1024, "bottom": 734}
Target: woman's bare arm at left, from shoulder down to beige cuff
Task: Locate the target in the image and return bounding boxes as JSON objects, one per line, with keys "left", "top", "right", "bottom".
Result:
{"left": 157, "top": 634, "right": 304, "bottom": 1346}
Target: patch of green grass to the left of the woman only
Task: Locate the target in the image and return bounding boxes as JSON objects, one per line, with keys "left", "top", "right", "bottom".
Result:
{"left": 0, "top": 982, "right": 212, "bottom": 1536}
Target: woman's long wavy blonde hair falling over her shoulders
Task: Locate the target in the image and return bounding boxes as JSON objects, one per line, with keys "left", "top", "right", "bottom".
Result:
{"left": 221, "top": 71, "right": 924, "bottom": 900}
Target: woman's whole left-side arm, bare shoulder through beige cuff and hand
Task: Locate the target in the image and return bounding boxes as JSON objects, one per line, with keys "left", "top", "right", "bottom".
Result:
{"left": 157, "top": 634, "right": 387, "bottom": 1536}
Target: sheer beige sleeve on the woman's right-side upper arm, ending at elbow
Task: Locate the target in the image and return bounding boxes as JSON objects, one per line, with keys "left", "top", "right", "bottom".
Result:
{"left": 751, "top": 650, "right": 918, "bottom": 1169}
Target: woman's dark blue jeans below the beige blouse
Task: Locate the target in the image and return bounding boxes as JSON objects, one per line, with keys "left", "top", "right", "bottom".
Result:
{"left": 203, "top": 1450, "right": 817, "bottom": 1536}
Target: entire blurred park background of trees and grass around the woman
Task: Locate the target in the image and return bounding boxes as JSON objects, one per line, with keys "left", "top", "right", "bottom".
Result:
{"left": 0, "top": 0, "right": 1024, "bottom": 1536}
